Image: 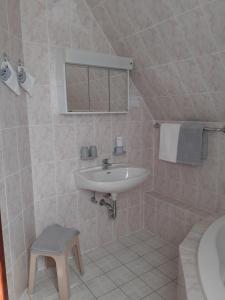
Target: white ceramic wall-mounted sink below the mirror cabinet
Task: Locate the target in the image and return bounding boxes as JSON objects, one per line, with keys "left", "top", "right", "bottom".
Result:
{"left": 74, "top": 164, "right": 150, "bottom": 198}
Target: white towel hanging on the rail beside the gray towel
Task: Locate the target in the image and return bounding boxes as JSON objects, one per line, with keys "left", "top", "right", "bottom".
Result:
{"left": 159, "top": 123, "right": 181, "bottom": 163}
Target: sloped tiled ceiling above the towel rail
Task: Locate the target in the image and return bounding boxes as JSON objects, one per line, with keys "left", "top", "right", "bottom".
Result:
{"left": 86, "top": 0, "right": 225, "bottom": 121}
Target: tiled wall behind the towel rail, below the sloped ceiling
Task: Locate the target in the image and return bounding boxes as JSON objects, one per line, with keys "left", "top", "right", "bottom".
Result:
{"left": 155, "top": 123, "right": 225, "bottom": 215}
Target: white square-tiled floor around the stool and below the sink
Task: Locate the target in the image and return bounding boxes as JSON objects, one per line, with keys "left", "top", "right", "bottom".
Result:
{"left": 26, "top": 231, "right": 178, "bottom": 300}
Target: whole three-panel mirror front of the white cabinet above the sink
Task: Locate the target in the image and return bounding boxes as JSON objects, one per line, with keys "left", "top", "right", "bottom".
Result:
{"left": 65, "top": 63, "right": 129, "bottom": 113}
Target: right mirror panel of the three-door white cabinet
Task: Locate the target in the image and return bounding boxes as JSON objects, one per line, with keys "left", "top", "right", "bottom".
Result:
{"left": 109, "top": 69, "right": 128, "bottom": 112}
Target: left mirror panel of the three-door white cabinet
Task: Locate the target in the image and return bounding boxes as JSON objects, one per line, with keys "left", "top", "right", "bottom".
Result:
{"left": 65, "top": 63, "right": 90, "bottom": 112}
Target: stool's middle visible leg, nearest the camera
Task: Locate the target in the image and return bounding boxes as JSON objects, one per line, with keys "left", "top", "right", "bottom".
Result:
{"left": 54, "top": 254, "right": 70, "bottom": 300}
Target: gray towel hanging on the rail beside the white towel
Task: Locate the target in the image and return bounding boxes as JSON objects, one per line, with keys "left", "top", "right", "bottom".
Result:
{"left": 177, "top": 123, "right": 208, "bottom": 166}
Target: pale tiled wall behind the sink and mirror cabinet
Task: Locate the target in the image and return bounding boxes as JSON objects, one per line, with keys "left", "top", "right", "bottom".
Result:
{"left": 21, "top": 0, "right": 153, "bottom": 250}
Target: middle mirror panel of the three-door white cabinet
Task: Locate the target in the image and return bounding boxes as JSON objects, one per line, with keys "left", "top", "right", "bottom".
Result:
{"left": 89, "top": 67, "right": 110, "bottom": 112}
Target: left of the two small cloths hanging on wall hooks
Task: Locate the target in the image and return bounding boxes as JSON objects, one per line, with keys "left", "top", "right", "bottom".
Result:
{"left": 0, "top": 61, "right": 20, "bottom": 95}
